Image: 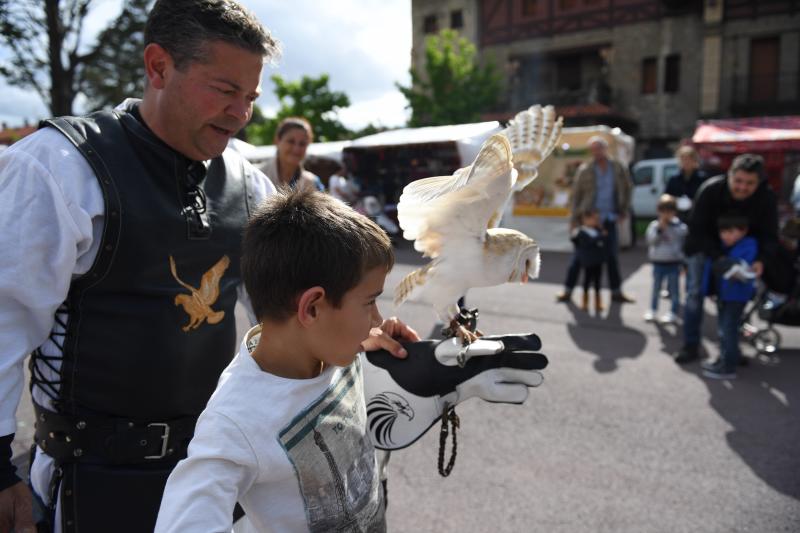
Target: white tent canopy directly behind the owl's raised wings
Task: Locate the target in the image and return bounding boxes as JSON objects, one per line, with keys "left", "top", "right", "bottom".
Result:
{"left": 350, "top": 120, "right": 502, "bottom": 165}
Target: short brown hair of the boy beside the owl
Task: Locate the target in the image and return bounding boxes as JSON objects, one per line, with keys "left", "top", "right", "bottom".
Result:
{"left": 241, "top": 190, "right": 394, "bottom": 322}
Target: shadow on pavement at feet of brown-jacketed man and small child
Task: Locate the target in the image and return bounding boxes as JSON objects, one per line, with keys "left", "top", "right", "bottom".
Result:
{"left": 566, "top": 293, "right": 647, "bottom": 373}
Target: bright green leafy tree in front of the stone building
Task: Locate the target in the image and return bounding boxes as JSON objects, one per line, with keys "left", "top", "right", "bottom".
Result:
{"left": 396, "top": 29, "right": 500, "bottom": 127}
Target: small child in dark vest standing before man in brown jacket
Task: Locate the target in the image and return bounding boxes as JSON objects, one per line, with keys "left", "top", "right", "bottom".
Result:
{"left": 571, "top": 208, "right": 608, "bottom": 313}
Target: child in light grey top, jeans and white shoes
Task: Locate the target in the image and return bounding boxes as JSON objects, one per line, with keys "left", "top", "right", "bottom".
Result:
{"left": 644, "top": 194, "right": 688, "bottom": 324}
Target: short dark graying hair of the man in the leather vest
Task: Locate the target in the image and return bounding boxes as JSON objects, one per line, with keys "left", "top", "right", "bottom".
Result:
{"left": 144, "top": 0, "right": 280, "bottom": 70}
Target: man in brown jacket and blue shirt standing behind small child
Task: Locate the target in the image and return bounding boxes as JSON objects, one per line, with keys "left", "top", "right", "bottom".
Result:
{"left": 556, "top": 136, "right": 634, "bottom": 303}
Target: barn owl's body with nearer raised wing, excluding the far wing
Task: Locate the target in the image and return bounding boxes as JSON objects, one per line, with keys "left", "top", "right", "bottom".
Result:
{"left": 395, "top": 133, "right": 539, "bottom": 343}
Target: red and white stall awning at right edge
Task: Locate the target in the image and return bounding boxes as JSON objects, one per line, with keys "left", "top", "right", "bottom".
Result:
{"left": 692, "top": 116, "right": 800, "bottom": 152}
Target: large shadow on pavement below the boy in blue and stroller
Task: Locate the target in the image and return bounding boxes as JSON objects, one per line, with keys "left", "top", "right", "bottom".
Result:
{"left": 683, "top": 350, "right": 800, "bottom": 500}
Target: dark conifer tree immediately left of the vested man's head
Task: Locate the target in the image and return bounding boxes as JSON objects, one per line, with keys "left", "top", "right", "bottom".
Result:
{"left": 81, "top": 0, "right": 153, "bottom": 109}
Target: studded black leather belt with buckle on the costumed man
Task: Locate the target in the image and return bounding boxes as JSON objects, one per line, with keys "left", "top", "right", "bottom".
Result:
{"left": 33, "top": 404, "right": 197, "bottom": 464}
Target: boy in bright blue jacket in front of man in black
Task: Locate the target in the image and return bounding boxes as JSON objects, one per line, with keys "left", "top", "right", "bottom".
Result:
{"left": 701, "top": 214, "right": 758, "bottom": 379}
